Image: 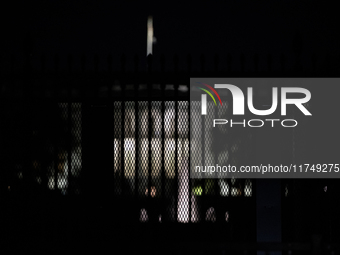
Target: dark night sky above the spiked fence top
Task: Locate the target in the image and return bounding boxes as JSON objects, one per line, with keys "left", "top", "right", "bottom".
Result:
{"left": 2, "top": 0, "right": 340, "bottom": 71}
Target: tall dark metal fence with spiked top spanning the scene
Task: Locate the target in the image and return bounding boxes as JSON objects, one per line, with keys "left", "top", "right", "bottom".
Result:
{"left": 0, "top": 53, "right": 339, "bottom": 253}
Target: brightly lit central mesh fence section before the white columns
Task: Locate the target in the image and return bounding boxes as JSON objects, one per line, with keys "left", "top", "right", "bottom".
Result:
{"left": 113, "top": 95, "right": 252, "bottom": 223}
